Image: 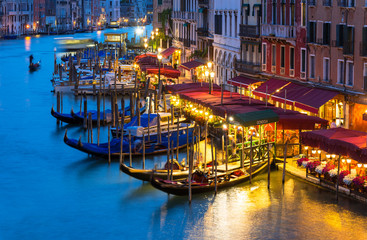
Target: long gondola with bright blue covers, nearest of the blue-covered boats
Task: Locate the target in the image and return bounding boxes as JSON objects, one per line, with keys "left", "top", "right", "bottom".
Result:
{"left": 64, "top": 125, "right": 196, "bottom": 158}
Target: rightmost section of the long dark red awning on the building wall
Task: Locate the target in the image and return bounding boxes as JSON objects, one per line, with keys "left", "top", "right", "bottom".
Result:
{"left": 295, "top": 88, "right": 338, "bottom": 113}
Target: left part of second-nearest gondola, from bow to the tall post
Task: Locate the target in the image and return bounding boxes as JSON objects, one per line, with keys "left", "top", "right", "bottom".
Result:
{"left": 120, "top": 163, "right": 189, "bottom": 182}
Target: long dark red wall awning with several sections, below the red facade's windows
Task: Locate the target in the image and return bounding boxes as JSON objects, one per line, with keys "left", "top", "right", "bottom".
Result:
{"left": 253, "top": 78, "right": 338, "bottom": 114}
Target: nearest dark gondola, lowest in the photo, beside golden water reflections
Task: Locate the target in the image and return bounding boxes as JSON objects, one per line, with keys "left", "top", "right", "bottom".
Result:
{"left": 151, "top": 161, "right": 268, "bottom": 196}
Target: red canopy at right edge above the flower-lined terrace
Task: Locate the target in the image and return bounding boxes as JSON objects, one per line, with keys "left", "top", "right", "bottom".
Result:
{"left": 301, "top": 128, "right": 367, "bottom": 163}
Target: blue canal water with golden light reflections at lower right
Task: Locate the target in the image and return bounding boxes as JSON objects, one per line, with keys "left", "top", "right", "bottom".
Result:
{"left": 0, "top": 28, "right": 367, "bottom": 239}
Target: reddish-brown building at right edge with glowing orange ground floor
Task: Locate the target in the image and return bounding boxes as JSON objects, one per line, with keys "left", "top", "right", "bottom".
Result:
{"left": 307, "top": 0, "right": 367, "bottom": 131}
